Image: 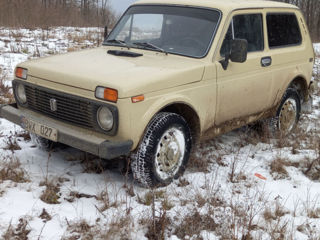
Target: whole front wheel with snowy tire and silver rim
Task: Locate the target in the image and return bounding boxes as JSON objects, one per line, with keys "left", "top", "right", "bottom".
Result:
{"left": 131, "top": 112, "right": 192, "bottom": 187}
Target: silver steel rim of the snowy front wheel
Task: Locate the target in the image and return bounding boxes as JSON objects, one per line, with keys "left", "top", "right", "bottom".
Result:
{"left": 155, "top": 128, "right": 186, "bottom": 179}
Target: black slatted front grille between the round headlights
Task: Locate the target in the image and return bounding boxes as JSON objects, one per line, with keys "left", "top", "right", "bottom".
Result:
{"left": 25, "top": 85, "right": 98, "bottom": 128}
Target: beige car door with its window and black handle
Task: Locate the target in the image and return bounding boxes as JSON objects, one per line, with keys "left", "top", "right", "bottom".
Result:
{"left": 215, "top": 10, "right": 272, "bottom": 125}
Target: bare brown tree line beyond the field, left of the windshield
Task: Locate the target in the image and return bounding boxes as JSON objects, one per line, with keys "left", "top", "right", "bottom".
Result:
{"left": 0, "top": 0, "right": 116, "bottom": 28}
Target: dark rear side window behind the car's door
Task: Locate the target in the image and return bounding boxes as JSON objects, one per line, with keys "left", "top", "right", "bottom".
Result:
{"left": 267, "top": 14, "right": 302, "bottom": 48}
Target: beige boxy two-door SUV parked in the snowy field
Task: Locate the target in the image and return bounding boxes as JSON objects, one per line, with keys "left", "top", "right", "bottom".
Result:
{"left": 0, "top": 0, "right": 314, "bottom": 187}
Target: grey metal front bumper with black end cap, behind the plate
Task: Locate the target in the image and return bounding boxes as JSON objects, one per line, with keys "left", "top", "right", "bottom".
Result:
{"left": 0, "top": 104, "right": 133, "bottom": 159}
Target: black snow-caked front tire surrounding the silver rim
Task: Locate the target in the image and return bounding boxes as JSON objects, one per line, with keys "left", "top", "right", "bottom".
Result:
{"left": 131, "top": 112, "right": 192, "bottom": 188}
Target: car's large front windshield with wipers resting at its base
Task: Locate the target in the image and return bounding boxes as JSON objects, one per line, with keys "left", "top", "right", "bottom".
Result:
{"left": 104, "top": 5, "right": 220, "bottom": 58}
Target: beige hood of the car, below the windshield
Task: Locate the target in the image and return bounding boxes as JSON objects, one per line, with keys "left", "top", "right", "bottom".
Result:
{"left": 20, "top": 47, "right": 205, "bottom": 98}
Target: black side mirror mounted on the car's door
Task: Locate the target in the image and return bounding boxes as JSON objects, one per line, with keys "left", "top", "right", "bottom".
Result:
{"left": 220, "top": 38, "right": 248, "bottom": 70}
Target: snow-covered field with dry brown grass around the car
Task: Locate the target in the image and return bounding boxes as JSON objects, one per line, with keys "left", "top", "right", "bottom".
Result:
{"left": 0, "top": 28, "right": 320, "bottom": 240}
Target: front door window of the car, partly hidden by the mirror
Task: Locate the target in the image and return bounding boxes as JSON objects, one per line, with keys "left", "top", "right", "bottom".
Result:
{"left": 220, "top": 14, "right": 264, "bottom": 56}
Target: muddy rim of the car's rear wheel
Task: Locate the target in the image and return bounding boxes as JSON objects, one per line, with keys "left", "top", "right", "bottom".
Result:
{"left": 279, "top": 98, "right": 297, "bottom": 133}
